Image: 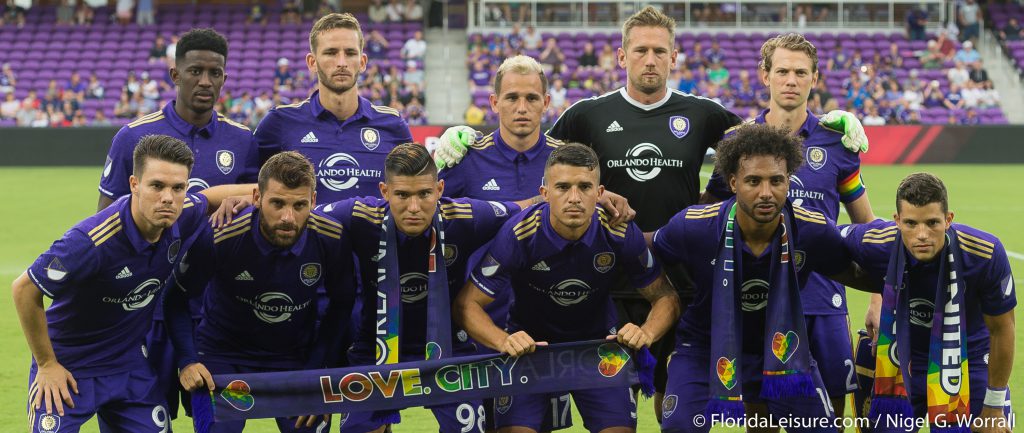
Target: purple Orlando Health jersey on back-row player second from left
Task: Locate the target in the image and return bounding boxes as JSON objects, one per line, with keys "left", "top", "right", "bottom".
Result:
{"left": 253, "top": 91, "right": 413, "bottom": 203}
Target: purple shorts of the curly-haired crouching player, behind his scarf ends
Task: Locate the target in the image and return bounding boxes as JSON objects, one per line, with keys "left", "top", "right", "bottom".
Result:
{"left": 662, "top": 345, "right": 836, "bottom": 433}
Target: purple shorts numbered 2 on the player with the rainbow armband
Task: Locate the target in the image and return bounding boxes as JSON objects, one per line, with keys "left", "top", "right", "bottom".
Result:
{"left": 804, "top": 314, "right": 857, "bottom": 398}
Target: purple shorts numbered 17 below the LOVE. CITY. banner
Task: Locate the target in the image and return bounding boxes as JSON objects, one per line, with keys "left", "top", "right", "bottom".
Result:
{"left": 495, "top": 388, "right": 637, "bottom": 432}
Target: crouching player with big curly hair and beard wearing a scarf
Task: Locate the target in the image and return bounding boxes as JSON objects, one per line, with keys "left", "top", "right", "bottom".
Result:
{"left": 652, "top": 125, "right": 871, "bottom": 432}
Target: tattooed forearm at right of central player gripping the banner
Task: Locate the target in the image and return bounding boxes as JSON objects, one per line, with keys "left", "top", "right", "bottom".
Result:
{"left": 614, "top": 272, "right": 681, "bottom": 350}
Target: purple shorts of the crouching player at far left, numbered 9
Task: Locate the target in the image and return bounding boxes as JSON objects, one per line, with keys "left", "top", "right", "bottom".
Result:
{"left": 27, "top": 369, "right": 171, "bottom": 433}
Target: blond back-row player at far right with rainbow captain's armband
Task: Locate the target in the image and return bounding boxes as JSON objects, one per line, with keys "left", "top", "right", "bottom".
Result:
{"left": 701, "top": 33, "right": 874, "bottom": 417}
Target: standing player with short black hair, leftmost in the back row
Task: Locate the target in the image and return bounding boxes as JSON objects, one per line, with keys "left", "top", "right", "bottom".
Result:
{"left": 98, "top": 29, "right": 259, "bottom": 210}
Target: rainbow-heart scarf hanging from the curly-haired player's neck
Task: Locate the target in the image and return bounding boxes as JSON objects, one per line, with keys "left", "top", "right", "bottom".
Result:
{"left": 706, "top": 199, "right": 816, "bottom": 419}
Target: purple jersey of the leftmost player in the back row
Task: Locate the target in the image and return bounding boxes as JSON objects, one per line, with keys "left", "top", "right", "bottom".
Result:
{"left": 99, "top": 100, "right": 259, "bottom": 199}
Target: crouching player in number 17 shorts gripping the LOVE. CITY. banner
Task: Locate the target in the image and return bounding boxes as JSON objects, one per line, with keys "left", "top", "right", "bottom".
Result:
{"left": 456, "top": 143, "right": 680, "bottom": 433}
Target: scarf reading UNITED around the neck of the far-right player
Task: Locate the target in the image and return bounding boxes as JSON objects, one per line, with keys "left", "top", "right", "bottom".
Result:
{"left": 869, "top": 227, "right": 971, "bottom": 433}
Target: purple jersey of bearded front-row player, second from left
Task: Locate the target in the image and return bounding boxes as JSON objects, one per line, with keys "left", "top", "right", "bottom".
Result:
{"left": 174, "top": 207, "right": 355, "bottom": 370}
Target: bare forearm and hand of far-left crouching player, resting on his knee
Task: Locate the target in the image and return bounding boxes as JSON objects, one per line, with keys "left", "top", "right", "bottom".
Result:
{"left": 11, "top": 273, "right": 78, "bottom": 417}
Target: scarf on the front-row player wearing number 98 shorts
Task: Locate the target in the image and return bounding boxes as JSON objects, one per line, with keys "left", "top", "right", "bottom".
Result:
{"left": 376, "top": 209, "right": 452, "bottom": 365}
